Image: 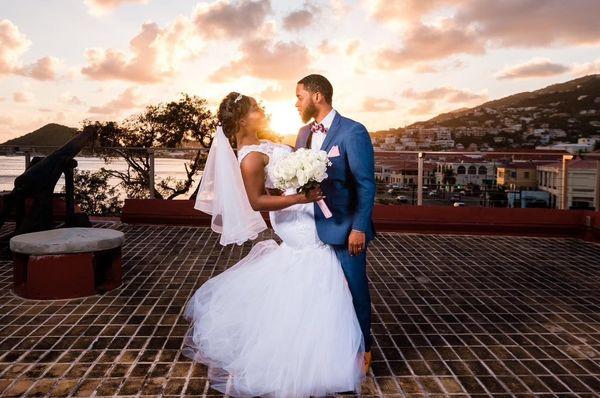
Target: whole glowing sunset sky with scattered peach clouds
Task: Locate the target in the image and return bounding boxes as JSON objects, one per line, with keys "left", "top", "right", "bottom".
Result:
{"left": 0, "top": 0, "right": 600, "bottom": 142}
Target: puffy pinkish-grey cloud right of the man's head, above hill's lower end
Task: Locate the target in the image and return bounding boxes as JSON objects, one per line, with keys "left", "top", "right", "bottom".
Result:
{"left": 376, "top": 21, "right": 485, "bottom": 69}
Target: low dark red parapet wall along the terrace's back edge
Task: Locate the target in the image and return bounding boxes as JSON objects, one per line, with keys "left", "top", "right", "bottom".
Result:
{"left": 121, "top": 199, "right": 600, "bottom": 241}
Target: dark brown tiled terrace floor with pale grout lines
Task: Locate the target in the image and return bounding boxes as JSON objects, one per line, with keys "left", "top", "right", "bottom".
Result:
{"left": 0, "top": 224, "right": 600, "bottom": 397}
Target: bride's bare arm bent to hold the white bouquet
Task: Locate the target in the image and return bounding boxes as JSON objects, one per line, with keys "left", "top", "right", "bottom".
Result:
{"left": 240, "top": 152, "right": 322, "bottom": 211}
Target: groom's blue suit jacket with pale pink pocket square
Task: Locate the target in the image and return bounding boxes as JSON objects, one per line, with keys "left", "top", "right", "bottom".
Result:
{"left": 296, "top": 112, "right": 375, "bottom": 245}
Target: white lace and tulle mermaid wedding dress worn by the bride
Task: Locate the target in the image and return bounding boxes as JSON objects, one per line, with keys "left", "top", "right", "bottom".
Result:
{"left": 184, "top": 141, "right": 364, "bottom": 398}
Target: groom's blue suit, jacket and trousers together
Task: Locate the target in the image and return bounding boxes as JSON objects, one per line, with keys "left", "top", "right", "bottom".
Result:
{"left": 296, "top": 112, "right": 375, "bottom": 351}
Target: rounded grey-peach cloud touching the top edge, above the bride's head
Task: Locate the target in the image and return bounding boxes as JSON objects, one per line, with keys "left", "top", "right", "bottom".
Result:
{"left": 192, "top": 0, "right": 272, "bottom": 39}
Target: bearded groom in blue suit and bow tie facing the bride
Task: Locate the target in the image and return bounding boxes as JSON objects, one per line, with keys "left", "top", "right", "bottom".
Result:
{"left": 296, "top": 75, "right": 375, "bottom": 373}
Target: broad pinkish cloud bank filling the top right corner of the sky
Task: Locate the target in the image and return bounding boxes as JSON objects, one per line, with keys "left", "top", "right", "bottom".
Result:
{"left": 365, "top": 0, "right": 600, "bottom": 69}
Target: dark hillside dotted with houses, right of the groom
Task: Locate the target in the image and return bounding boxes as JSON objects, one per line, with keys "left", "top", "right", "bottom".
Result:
{"left": 372, "top": 74, "right": 600, "bottom": 150}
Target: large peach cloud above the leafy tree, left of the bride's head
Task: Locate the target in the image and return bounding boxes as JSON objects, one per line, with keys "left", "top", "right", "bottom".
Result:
{"left": 81, "top": 17, "right": 199, "bottom": 84}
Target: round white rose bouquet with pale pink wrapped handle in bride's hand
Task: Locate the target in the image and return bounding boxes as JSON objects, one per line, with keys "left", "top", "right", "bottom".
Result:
{"left": 269, "top": 148, "right": 332, "bottom": 218}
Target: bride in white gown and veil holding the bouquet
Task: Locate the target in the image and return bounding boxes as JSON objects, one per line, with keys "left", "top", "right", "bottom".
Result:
{"left": 184, "top": 93, "right": 364, "bottom": 398}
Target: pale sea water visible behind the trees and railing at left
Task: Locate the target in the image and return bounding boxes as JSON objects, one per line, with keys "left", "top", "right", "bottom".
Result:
{"left": 0, "top": 156, "right": 201, "bottom": 199}
